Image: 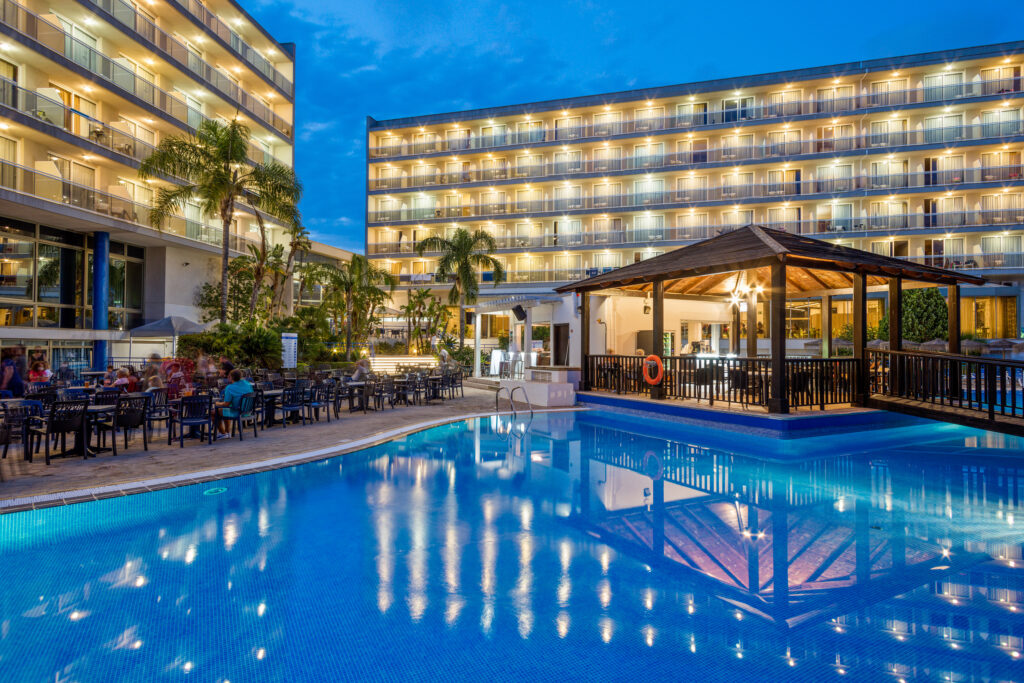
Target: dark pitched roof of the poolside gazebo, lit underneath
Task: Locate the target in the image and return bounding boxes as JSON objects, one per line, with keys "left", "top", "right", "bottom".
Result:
{"left": 556, "top": 225, "right": 985, "bottom": 296}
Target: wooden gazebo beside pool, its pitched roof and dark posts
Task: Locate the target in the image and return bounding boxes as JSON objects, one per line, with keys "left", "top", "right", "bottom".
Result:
{"left": 557, "top": 225, "right": 985, "bottom": 413}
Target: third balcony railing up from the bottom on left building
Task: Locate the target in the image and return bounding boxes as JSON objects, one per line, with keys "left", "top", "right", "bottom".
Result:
{"left": 0, "top": 0, "right": 292, "bottom": 147}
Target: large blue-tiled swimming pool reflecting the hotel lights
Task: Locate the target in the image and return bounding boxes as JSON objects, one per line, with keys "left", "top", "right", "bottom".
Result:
{"left": 0, "top": 412, "right": 1024, "bottom": 683}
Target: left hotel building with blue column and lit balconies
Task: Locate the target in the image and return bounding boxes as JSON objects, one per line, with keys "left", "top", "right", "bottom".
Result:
{"left": 0, "top": 0, "right": 331, "bottom": 365}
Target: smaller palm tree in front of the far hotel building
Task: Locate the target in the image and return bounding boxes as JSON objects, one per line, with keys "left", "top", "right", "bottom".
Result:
{"left": 416, "top": 227, "right": 505, "bottom": 348}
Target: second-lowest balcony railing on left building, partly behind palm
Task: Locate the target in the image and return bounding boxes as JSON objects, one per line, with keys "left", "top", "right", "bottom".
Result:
{"left": 0, "top": 78, "right": 275, "bottom": 163}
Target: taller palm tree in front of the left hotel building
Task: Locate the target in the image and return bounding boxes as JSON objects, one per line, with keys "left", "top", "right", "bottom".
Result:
{"left": 138, "top": 119, "right": 302, "bottom": 323}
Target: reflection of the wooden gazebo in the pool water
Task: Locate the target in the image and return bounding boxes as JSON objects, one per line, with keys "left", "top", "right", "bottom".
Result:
{"left": 575, "top": 444, "right": 989, "bottom": 628}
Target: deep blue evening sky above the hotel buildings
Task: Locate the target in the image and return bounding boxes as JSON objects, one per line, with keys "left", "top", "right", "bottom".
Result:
{"left": 242, "top": 0, "right": 1024, "bottom": 252}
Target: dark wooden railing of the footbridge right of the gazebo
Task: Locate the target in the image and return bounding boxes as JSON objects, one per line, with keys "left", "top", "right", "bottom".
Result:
{"left": 867, "top": 349, "right": 1024, "bottom": 420}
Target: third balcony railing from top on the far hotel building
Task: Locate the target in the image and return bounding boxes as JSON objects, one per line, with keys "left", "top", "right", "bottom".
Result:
{"left": 369, "top": 165, "right": 1024, "bottom": 223}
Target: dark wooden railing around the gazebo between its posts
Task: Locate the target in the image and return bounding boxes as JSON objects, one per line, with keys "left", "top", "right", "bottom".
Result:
{"left": 587, "top": 355, "right": 859, "bottom": 410}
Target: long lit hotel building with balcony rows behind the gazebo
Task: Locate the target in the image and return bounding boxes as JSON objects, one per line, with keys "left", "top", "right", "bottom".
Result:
{"left": 367, "top": 42, "right": 1024, "bottom": 338}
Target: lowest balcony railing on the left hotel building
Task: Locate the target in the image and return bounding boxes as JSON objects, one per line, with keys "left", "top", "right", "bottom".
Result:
{"left": 0, "top": 156, "right": 258, "bottom": 252}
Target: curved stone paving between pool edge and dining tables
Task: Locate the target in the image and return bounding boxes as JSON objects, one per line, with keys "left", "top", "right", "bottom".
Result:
{"left": 0, "top": 387, "right": 495, "bottom": 500}
